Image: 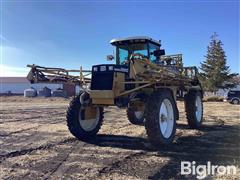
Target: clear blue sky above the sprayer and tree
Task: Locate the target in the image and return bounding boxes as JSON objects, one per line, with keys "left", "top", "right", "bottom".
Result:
{"left": 0, "top": 0, "right": 240, "bottom": 76}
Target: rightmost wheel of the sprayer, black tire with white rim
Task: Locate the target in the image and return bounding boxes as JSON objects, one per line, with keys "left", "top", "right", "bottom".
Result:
{"left": 184, "top": 91, "right": 203, "bottom": 129}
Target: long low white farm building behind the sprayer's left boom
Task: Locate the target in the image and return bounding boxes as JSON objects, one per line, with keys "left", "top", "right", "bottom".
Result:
{"left": 0, "top": 77, "right": 76, "bottom": 96}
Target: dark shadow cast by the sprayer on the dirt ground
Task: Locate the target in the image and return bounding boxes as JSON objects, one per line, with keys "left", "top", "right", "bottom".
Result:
{"left": 89, "top": 124, "right": 240, "bottom": 179}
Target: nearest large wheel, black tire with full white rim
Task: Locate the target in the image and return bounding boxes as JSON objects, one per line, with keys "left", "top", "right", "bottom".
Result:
{"left": 145, "top": 89, "right": 177, "bottom": 147}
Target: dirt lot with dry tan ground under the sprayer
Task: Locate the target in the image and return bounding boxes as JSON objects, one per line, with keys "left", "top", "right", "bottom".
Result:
{"left": 0, "top": 97, "right": 240, "bottom": 179}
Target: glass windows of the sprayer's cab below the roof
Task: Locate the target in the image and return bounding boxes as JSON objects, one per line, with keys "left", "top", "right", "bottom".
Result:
{"left": 117, "top": 43, "right": 148, "bottom": 64}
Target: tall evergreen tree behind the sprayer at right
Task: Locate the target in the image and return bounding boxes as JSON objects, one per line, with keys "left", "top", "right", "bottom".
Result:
{"left": 200, "top": 33, "right": 236, "bottom": 92}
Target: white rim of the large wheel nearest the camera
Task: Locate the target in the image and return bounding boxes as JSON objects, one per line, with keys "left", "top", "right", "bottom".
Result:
{"left": 159, "top": 99, "right": 174, "bottom": 138}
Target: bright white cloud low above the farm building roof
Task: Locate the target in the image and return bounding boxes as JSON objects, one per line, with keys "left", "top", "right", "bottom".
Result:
{"left": 0, "top": 64, "right": 30, "bottom": 77}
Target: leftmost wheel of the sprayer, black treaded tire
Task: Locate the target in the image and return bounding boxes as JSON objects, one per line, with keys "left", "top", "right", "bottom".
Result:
{"left": 66, "top": 94, "right": 103, "bottom": 140}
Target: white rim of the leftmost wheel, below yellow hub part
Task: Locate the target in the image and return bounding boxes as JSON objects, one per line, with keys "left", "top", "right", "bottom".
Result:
{"left": 78, "top": 107, "right": 100, "bottom": 131}
